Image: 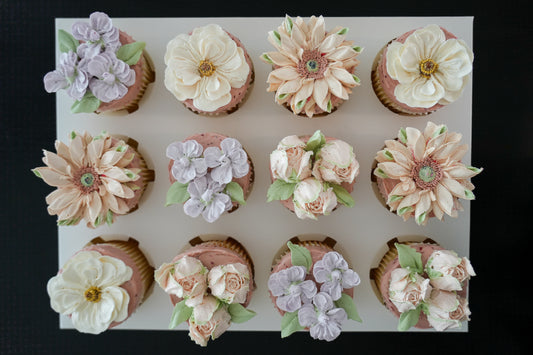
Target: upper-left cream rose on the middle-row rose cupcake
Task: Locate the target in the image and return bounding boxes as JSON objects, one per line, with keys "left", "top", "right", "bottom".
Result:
{"left": 270, "top": 136, "right": 313, "bottom": 182}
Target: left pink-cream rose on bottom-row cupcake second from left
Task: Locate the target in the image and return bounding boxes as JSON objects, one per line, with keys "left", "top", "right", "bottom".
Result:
{"left": 154, "top": 256, "right": 207, "bottom": 307}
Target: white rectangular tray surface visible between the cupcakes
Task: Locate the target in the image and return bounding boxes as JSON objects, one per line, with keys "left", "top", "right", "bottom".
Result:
{"left": 51, "top": 17, "right": 473, "bottom": 332}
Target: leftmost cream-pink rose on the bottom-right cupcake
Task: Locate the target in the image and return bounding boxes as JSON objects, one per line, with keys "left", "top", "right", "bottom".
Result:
{"left": 389, "top": 268, "right": 432, "bottom": 313}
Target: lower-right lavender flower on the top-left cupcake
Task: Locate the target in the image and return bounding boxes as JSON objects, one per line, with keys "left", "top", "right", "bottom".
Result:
{"left": 87, "top": 52, "right": 135, "bottom": 102}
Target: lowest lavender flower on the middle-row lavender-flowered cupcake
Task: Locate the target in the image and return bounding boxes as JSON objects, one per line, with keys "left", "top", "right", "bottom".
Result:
{"left": 183, "top": 175, "right": 233, "bottom": 223}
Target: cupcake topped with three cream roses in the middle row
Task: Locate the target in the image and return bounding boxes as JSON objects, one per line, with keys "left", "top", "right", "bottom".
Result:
{"left": 267, "top": 131, "right": 359, "bottom": 220}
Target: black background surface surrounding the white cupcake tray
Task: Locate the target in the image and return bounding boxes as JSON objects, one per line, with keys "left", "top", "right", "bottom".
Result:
{"left": 0, "top": 0, "right": 533, "bottom": 355}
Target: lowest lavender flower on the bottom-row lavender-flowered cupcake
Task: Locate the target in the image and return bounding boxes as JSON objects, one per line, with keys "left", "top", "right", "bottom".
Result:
{"left": 298, "top": 292, "right": 348, "bottom": 341}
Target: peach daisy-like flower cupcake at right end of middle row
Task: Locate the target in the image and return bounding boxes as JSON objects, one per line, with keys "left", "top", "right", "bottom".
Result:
{"left": 372, "top": 122, "right": 483, "bottom": 225}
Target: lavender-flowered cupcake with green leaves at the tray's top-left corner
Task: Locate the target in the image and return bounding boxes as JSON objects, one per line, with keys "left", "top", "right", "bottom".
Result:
{"left": 44, "top": 12, "right": 155, "bottom": 113}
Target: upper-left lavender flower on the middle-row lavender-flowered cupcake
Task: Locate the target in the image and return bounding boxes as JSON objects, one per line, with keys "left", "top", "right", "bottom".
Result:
{"left": 167, "top": 140, "right": 207, "bottom": 184}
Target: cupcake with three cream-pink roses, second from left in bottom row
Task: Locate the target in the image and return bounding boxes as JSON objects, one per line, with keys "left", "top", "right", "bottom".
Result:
{"left": 155, "top": 235, "right": 255, "bottom": 346}
